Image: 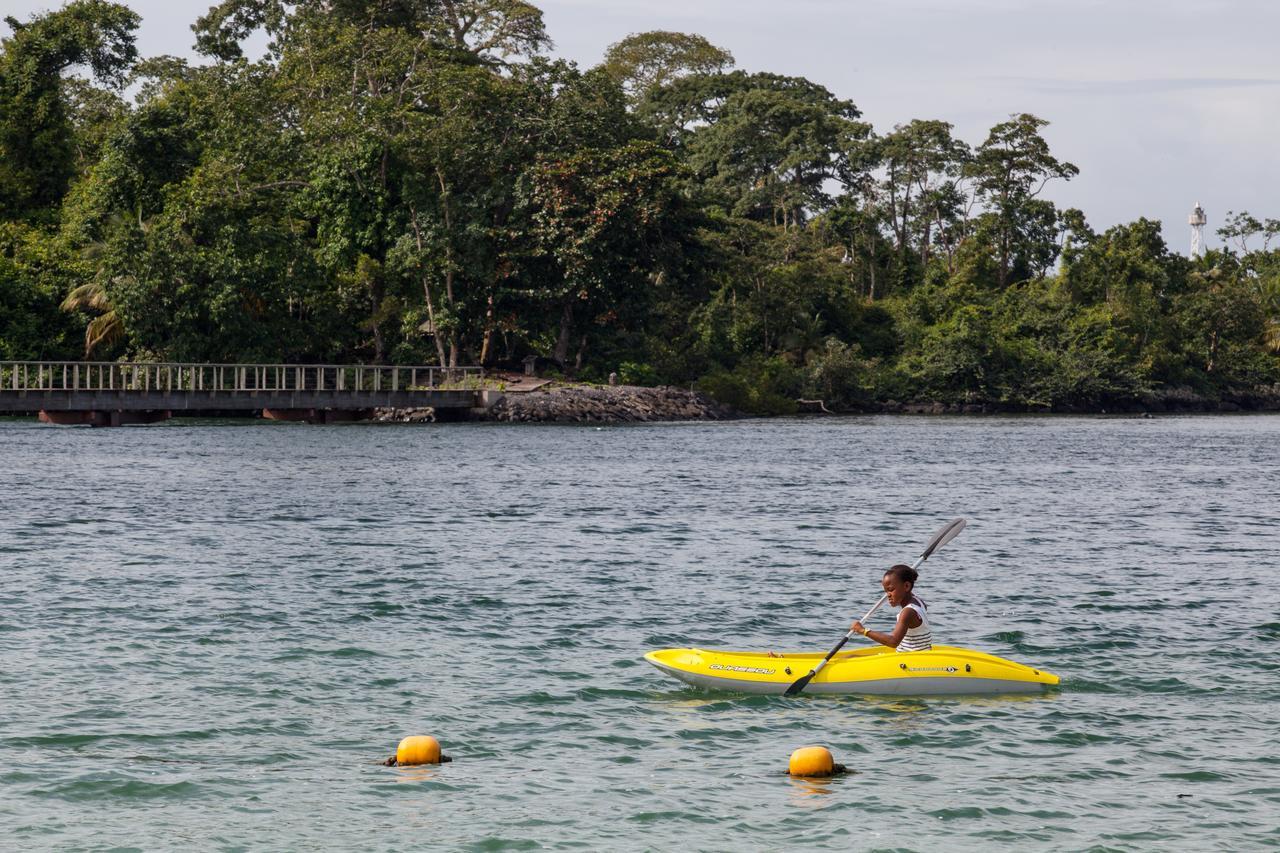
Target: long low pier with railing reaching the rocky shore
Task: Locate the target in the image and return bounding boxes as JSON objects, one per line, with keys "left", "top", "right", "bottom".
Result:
{"left": 0, "top": 361, "right": 493, "bottom": 427}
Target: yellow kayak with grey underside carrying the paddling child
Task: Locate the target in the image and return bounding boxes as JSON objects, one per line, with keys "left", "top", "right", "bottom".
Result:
{"left": 644, "top": 646, "right": 1059, "bottom": 695}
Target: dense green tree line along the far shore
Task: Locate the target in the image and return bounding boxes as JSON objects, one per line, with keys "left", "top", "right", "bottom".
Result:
{"left": 0, "top": 0, "right": 1280, "bottom": 412}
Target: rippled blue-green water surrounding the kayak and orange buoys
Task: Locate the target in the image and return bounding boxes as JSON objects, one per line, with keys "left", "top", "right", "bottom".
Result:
{"left": 0, "top": 416, "right": 1280, "bottom": 850}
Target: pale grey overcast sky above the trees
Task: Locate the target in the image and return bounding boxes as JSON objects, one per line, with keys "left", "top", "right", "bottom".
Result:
{"left": 0, "top": 0, "right": 1280, "bottom": 252}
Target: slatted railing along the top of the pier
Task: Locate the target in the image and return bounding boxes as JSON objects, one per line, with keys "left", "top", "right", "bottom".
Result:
{"left": 0, "top": 361, "right": 484, "bottom": 393}
